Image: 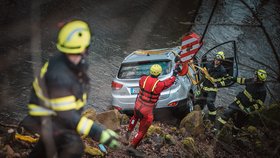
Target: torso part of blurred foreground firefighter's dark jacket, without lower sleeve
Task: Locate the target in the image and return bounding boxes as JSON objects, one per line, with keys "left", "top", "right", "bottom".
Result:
{"left": 28, "top": 55, "right": 88, "bottom": 116}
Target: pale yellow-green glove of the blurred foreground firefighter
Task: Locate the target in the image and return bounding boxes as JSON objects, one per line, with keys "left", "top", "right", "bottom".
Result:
{"left": 99, "top": 129, "right": 120, "bottom": 149}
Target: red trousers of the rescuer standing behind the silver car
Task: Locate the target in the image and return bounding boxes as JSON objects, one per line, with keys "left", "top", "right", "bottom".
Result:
{"left": 128, "top": 102, "right": 154, "bottom": 148}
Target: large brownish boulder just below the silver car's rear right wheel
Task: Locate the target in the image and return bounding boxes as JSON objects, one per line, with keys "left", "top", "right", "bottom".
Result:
{"left": 180, "top": 111, "right": 204, "bottom": 136}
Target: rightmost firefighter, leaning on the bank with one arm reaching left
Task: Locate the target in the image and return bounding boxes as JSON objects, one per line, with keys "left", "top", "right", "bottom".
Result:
{"left": 214, "top": 69, "right": 267, "bottom": 134}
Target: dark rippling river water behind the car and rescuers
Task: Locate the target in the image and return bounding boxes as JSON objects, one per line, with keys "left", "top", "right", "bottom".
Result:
{"left": 0, "top": 0, "right": 280, "bottom": 123}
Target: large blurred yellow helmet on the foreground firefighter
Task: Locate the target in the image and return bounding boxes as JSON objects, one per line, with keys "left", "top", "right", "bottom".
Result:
{"left": 56, "top": 20, "right": 91, "bottom": 54}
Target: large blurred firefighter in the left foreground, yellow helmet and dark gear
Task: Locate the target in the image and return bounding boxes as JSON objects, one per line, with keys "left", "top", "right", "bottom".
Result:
{"left": 22, "top": 20, "right": 119, "bottom": 158}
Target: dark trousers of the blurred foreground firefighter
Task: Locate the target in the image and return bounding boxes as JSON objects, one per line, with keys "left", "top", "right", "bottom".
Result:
{"left": 22, "top": 116, "right": 84, "bottom": 158}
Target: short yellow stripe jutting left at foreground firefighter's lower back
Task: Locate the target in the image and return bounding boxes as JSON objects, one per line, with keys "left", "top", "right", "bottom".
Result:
{"left": 28, "top": 104, "right": 56, "bottom": 116}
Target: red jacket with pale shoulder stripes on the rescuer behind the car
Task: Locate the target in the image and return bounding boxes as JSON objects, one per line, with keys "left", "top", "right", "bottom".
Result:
{"left": 136, "top": 76, "right": 176, "bottom": 107}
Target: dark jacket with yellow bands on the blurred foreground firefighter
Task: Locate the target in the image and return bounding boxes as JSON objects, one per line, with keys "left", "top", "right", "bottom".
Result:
{"left": 28, "top": 54, "right": 103, "bottom": 141}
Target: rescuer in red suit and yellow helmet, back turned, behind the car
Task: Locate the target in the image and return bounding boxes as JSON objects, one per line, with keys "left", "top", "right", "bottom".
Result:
{"left": 126, "top": 64, "right": 178, "bottom": 149}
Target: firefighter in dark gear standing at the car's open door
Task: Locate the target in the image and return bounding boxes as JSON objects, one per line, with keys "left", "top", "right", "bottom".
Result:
{"left": 197, "top": 51, "right": 229, "bottom": 123}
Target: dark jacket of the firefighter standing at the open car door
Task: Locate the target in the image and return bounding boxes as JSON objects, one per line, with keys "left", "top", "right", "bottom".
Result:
{"left": 202, "top": 62, "right": 229, "bottom": 92}
